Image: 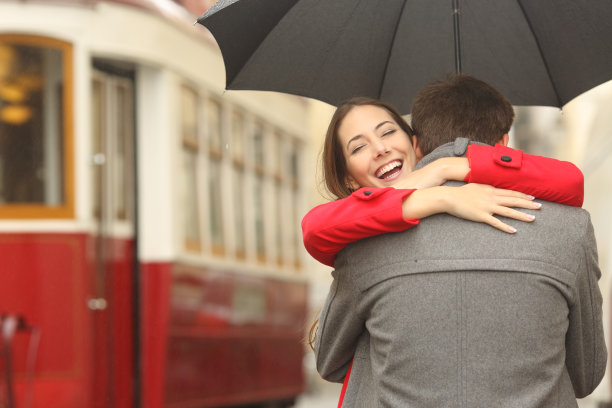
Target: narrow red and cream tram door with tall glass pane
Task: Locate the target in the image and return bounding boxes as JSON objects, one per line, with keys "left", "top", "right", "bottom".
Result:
{"left": 88, "top": 63, "right": 135, "bottom": 408}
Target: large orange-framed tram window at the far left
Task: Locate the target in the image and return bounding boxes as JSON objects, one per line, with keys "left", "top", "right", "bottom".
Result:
{"left": 0, "top": 35, "right": 73, "bottom": 218}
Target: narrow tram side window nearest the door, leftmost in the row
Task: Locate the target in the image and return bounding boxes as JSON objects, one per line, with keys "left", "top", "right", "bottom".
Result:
{"left": 181, "top": 86, "right": 201, "bottom": 252}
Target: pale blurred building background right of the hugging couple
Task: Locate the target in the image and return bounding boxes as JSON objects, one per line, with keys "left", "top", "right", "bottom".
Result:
{"left": 511, "top": 82, "right": 612, "bottom": 406}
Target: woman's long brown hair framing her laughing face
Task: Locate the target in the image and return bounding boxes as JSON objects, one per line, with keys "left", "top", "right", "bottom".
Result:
{"left": 321, "top": 96, "right": 414, "bottom": 198}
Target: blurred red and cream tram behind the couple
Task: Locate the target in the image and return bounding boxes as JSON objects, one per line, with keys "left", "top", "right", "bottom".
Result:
{"left": 0, "top": 0, "right": 309, "bottom": 408}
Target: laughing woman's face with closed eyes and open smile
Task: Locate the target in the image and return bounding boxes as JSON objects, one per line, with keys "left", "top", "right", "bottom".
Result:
{"left": 338, "top": 105, "right": 417, "bottom": 189}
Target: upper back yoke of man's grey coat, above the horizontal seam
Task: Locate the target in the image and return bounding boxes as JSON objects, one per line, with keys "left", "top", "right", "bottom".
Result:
{"left": 336, "top": 198, "right": 593, "bottom": 282}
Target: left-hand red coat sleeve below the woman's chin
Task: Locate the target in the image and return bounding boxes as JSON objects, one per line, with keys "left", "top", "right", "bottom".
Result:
{"left": 302, "top": 187, "right": 419, "bottom": 267}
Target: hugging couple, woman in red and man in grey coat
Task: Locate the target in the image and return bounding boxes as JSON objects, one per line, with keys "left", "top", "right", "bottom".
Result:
{"left": 302, "top": 75, "right": 607, "bottom": 408}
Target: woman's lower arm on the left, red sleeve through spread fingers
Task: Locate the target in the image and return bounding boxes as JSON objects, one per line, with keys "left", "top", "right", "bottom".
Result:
{"left": 302, "top": 184, "right": 540, "bottom": 266}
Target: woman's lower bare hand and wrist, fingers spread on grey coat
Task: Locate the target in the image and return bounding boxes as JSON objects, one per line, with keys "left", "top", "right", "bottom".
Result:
{"left": 402, "top": 183, "right": 541, "bottom": 234}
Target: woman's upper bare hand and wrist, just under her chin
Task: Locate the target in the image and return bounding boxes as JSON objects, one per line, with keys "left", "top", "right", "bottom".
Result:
{"left": 393, "top": 157, "right": 470, "bottom": 189}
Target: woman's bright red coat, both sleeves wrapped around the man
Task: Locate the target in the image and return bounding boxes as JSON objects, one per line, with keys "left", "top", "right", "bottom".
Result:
{"left": 302, "top": 145, "right": 584, "bottom": 267}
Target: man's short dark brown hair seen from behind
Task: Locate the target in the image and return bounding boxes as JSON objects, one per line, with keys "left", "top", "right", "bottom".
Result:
{"left": 411, "top": 75, "right": 514, "bottom": 155}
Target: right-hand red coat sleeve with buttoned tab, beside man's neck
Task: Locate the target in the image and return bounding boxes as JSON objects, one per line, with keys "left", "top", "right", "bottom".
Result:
{"left": 465, "top": 144, "right": 584, "bottom": 207}
